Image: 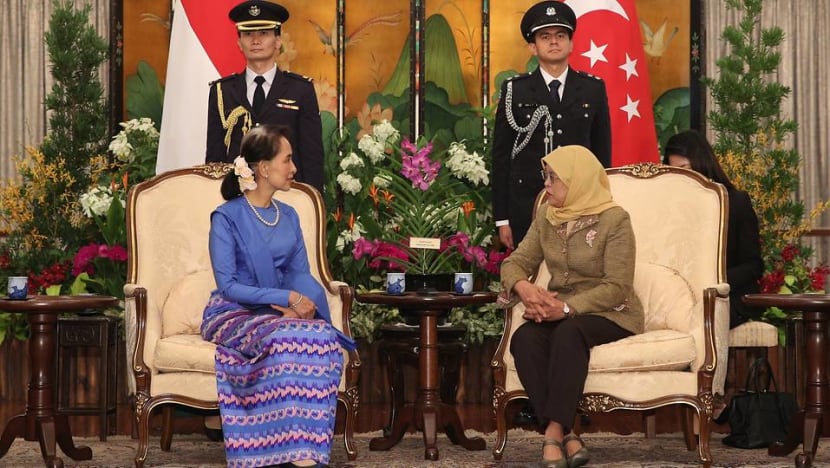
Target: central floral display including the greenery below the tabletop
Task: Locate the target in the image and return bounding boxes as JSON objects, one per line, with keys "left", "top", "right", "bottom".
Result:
{"left": 328, "top": 119, "right": 506, "bottom": 341}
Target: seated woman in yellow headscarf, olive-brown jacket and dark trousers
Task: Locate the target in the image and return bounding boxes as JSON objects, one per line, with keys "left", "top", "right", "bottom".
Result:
{"left": 501, "top": 146, "right": 644, "bottom": 468}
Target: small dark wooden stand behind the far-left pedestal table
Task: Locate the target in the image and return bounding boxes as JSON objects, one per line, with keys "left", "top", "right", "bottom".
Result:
{"left": 57, "top": 315, "right": 118, "bottom": 441}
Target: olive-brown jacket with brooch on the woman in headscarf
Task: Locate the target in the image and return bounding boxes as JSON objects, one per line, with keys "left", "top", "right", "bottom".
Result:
{"left": 501, "top": 204, "right": 644, "bottom": 333}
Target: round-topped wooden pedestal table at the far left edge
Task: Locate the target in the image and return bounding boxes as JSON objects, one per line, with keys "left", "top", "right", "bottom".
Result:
{"left": 0, "top": 296, "right": 118, "bottom": 468}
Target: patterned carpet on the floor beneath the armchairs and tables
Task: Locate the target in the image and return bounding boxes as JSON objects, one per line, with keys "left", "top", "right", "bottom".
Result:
{"left": 0, "top": 429, "right": 830, "bottom": 468}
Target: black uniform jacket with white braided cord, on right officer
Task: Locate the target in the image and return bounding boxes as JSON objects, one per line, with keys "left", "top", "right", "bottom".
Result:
{"left": 492, "top": 68, "right": 611, "bottom": 243}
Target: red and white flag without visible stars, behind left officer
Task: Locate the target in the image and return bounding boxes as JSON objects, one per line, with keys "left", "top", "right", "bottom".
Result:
{"left": 156, "top": 0, "right": 245, "bottom": 174}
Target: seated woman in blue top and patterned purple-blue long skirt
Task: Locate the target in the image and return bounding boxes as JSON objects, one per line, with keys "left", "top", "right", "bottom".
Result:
{"left": 201, "top": 125, "right": 354, "bottom": 467}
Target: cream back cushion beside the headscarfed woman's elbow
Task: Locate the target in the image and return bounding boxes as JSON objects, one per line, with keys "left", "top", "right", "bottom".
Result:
{"left": 634, "top": 262, "right": 699, "bottom": 333}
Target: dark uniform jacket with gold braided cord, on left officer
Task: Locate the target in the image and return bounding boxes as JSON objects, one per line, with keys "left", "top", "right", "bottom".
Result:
{"left": 205, "top": 70, "right": 323, "bottom": 192}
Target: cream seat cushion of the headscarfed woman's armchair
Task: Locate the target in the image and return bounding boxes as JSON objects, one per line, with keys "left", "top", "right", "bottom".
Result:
{"left": 588, "top": 330, "right": 696, "bottom": 372}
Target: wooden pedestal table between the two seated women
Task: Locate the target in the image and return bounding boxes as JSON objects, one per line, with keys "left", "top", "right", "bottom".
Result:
{"left": 355, "top": 292, "right": 496, "bottom": 460}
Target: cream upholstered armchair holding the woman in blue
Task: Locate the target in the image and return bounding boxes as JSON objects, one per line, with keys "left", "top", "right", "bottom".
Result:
{"left": 124, "top": 164, "right": 360, "bottom": 467}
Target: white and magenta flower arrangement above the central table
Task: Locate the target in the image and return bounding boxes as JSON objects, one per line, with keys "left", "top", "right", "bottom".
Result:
{"left": 335, "top": 120, "right": 499, "bottom": 274}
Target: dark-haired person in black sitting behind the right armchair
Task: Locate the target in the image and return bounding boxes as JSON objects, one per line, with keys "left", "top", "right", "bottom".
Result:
{"left": 663, "top": 130, "right": 764, "bottom": 328}
